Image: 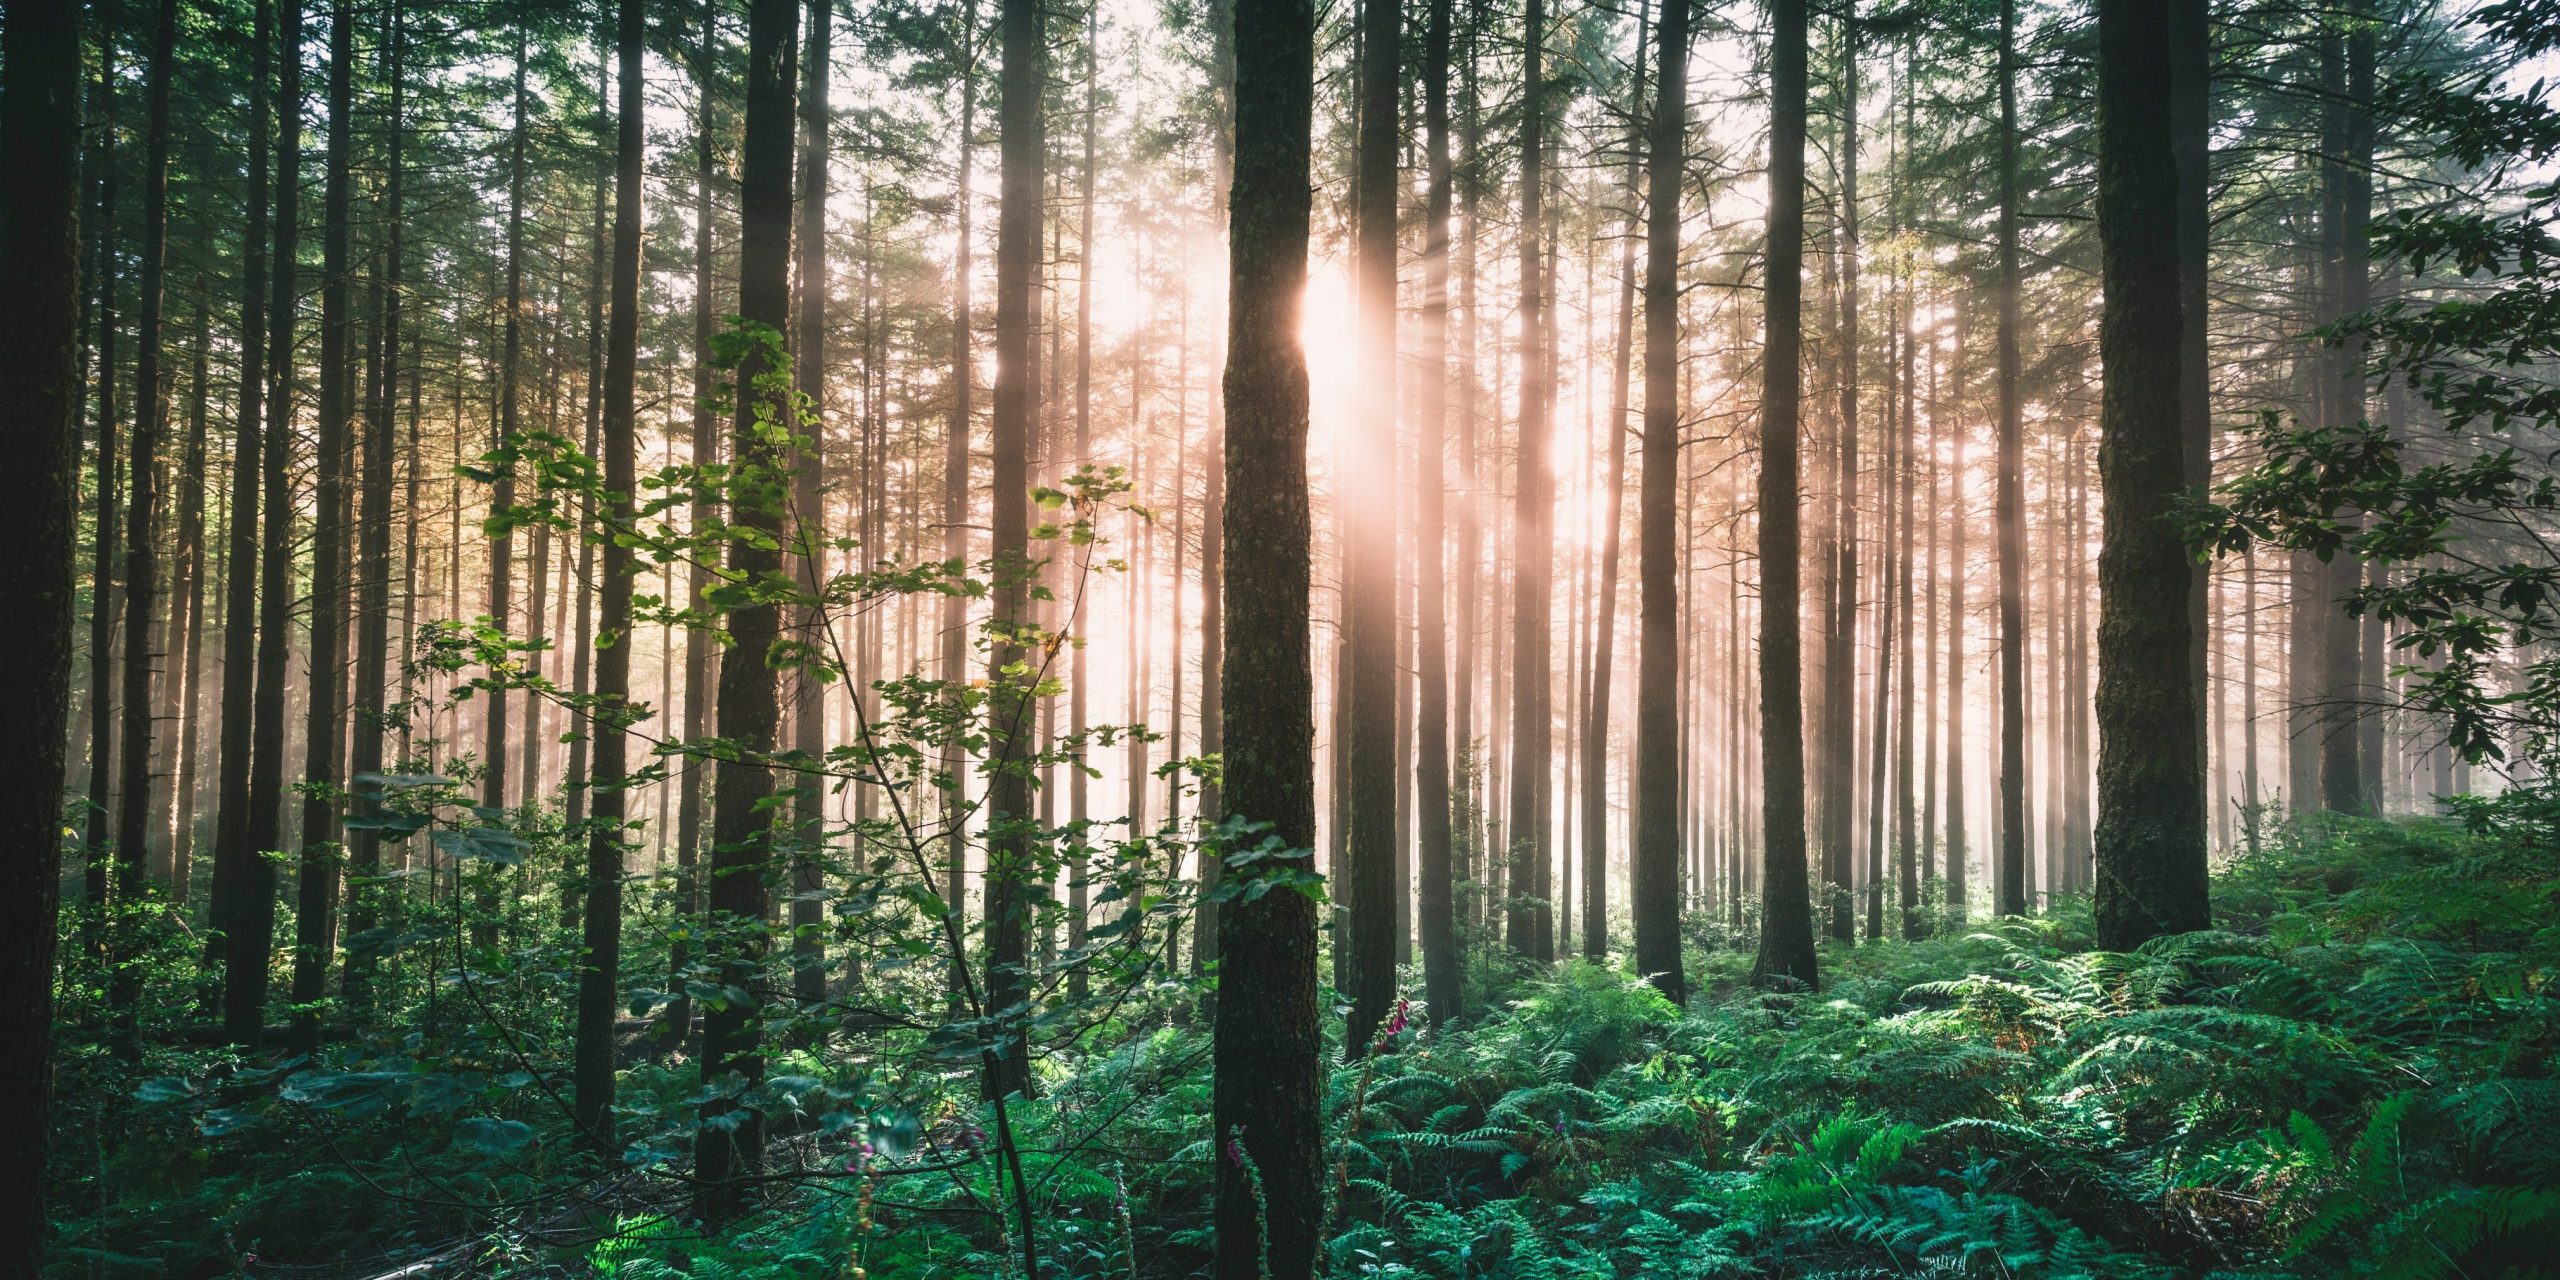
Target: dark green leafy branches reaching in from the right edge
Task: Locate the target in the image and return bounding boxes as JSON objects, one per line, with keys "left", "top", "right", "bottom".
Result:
{"left": 2189, "top": 0, "right": 2560, "bottom": 773}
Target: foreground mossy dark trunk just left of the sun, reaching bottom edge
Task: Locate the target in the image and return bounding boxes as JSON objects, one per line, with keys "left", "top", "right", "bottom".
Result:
{"left": 1211, "top": 0, "right": 1324, "bottom": 1264}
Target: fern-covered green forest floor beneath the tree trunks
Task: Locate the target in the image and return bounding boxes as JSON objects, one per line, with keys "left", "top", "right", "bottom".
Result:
{"left": 59, "top": 822, "right": 2560, "bottom": 1280}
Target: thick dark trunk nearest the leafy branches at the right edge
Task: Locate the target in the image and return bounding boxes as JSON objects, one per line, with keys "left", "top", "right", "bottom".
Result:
{"left": 2097, "top": 0, "right": 2207, "bottom": 950}
